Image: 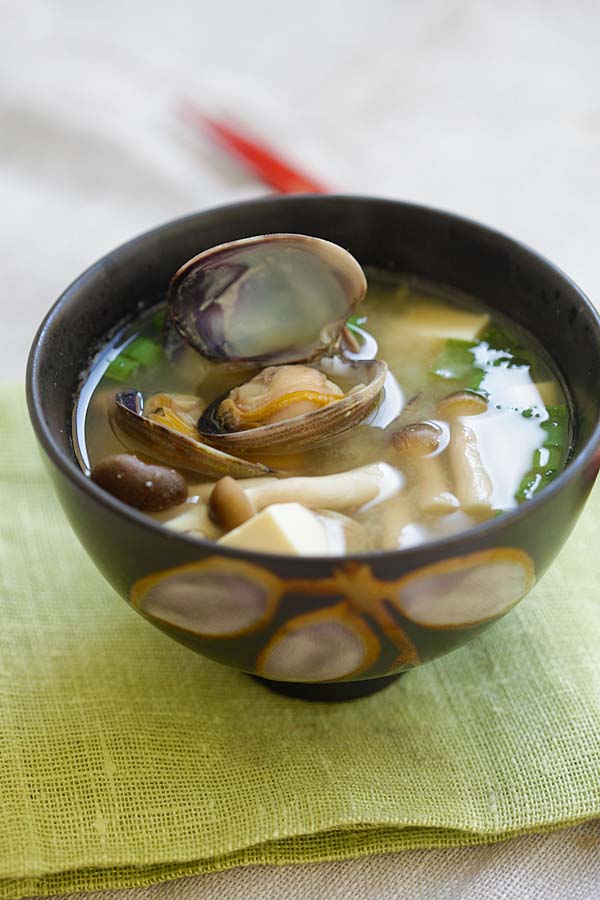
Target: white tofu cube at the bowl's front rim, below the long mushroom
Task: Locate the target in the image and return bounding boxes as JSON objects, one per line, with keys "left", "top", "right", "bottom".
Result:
{"left": 217, "top": 503, "right": 344, "bottom": 556}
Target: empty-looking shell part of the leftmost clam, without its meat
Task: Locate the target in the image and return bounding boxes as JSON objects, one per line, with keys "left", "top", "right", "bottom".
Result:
{"left": 111, "top": 391, "right": 271, "bottom": 478}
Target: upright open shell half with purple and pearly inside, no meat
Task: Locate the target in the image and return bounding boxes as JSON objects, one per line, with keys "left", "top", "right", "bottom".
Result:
{"left": 169, "top": 234, "right": 367, "bottom": 365}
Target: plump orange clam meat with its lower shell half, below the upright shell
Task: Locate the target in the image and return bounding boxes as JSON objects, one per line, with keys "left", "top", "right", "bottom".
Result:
{"left": 198, "top": 360, "right": 387, "bottom": 456}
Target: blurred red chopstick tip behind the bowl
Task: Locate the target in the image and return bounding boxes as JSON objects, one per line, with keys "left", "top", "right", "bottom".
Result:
{"left": 181, "top": 101, "right": 327, "bottom": 194}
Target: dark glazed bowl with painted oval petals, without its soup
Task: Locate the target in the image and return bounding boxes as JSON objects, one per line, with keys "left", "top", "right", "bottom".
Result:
{"left": 27, "top": 196, "right": 600, "bottom": 699}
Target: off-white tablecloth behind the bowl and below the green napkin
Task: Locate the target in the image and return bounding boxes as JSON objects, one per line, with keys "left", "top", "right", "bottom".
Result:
{"left": 0, "top": 0, "right": 600, "bottom": 900}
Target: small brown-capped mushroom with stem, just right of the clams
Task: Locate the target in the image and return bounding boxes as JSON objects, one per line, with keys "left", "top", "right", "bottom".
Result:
{"left": 392, "top": 422, "right": 459, "bottom": 515}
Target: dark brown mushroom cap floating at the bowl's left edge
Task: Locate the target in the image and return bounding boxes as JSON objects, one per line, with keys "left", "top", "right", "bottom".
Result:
{"left": 91, "top": 453, "right": 188, "bottom": 512}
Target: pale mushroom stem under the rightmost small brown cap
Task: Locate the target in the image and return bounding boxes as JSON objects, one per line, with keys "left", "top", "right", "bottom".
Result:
{"left": 448, "top": 421, "right": 493, "bottom": 514}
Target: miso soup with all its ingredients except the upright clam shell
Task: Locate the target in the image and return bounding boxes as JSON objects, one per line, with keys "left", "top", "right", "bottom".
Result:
{"left": 74, "top": 271, "right": 571, "bottom": 555}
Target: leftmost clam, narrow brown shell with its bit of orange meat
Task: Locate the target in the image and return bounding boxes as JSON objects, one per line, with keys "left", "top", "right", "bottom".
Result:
{"left": 111, "top": 391, "right": 270, "bottom": 478}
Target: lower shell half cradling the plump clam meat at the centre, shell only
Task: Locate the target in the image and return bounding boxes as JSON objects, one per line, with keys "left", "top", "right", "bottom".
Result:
{"left": 198, "top": 359, "right": 388, "bottom": 456}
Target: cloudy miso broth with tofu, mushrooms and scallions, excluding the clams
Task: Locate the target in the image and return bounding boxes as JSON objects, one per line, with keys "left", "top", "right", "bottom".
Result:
{"left": 74, "top": 271, "right": 571, "bottom": 555}
